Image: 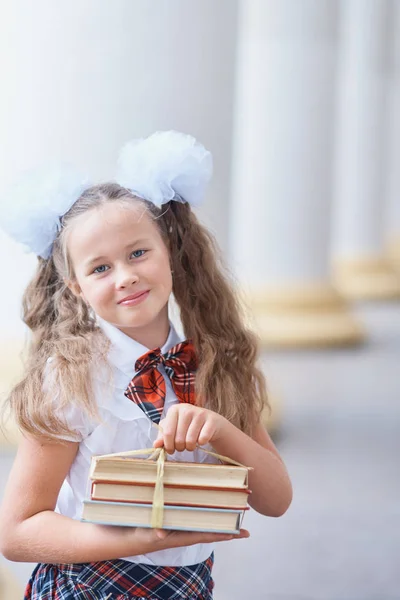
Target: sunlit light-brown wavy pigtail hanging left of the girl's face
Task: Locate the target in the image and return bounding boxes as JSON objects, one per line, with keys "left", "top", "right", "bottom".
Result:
{"left": 6, "top": 244, "right": 108, "bottom": 440}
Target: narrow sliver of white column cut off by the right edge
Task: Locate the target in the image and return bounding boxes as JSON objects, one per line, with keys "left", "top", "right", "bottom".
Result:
{"left": 385, "top": 0, "right": 400, "bottom": 269}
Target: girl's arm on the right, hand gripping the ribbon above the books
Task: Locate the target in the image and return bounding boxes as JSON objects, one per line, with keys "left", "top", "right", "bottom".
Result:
{"left": 154, "top": 404, "right": 292, "bottom": 517}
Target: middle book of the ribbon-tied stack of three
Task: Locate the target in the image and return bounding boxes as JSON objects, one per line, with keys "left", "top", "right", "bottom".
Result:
{"left": 91, "top": 481, "right": 249, "bottom": 509}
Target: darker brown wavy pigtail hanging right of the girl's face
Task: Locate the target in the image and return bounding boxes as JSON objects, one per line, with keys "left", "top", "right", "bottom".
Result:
{"left": 162, "top": 202, "right": 268, "bottom": 433}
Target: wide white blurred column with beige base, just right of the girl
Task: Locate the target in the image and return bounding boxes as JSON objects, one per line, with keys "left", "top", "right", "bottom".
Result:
{"left": 231, "top": 0, "right": 362, "bottom": 347}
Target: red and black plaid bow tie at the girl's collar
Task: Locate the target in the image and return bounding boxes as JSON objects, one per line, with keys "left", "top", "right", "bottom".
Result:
{"left": 125, "top": 340, "right": 197, "bottom": 423}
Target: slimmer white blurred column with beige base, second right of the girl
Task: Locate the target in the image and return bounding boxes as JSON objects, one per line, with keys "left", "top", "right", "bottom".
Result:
{"left": 333, "top": 0, "right": 400, "bottom": 299}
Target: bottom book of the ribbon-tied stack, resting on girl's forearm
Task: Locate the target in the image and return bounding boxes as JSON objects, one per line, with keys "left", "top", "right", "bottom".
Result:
{"left": 81, "top": 500, "right": 244, "bottom": 534}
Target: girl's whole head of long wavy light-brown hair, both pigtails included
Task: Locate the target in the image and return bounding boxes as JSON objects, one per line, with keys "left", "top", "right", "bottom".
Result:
{"left": 9, "top": 183, "right": 268, "bottom": 440}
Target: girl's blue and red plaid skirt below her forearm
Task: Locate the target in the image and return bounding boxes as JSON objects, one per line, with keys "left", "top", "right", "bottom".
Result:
{"left": 24, "top": 554, "right": 214, "bottom": 600}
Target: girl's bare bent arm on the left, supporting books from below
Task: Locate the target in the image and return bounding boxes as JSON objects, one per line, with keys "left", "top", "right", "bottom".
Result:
{"left": 0, "top": 437, "right": 248, "bottom": 563}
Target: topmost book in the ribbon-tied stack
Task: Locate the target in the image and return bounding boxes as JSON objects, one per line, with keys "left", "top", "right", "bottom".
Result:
{"left": 89, "top": 456, "right": 248, "bottom": 489}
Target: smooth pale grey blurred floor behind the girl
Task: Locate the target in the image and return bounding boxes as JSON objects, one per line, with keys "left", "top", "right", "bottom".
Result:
{"left": 0, "top": 304, "right": 400, "bottom": 600}
